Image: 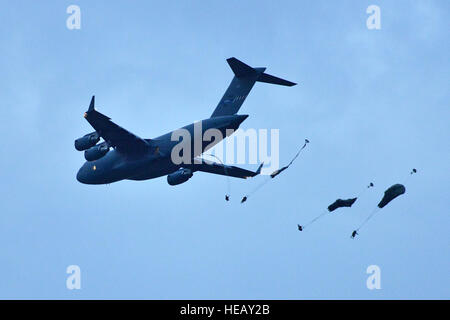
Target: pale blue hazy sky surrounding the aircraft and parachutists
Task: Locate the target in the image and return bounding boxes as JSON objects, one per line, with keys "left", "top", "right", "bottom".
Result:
{"left": 0, "top": 0, "right": 450, "bottom": 299}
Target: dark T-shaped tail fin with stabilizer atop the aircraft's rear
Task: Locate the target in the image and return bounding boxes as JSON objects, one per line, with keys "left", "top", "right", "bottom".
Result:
{"left": 211, "top": 57, "right": 296, "bottom": 118}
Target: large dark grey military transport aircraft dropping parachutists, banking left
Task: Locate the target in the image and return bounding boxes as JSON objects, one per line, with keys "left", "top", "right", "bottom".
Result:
{"left": 75, "top": 58, "right": 295, "bottom": 185}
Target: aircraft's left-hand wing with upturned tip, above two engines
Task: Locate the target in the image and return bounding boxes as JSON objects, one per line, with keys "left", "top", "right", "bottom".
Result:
{"left": 84, "top": 96, "right": 150, "bottom": 153}
